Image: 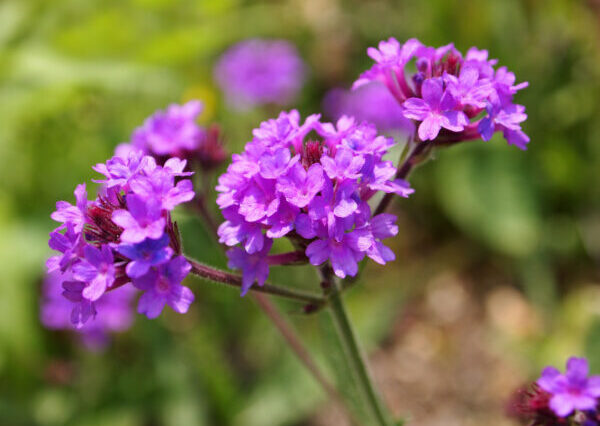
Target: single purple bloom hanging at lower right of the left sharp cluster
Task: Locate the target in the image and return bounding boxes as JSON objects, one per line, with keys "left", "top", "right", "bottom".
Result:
{"left": 133, "top": 256, "right": 194, "bottom": 319}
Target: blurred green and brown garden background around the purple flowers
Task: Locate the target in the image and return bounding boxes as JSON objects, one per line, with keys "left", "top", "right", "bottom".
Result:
{"left": 0, "top": 0, "right": 600, "bottom": 426}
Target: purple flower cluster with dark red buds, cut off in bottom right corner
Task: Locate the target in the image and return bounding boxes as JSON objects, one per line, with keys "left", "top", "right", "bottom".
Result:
{"left": 508, "top": 357, "right": 600, "bottom": 426}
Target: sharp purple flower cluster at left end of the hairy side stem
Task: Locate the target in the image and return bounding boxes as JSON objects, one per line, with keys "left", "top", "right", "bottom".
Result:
{"left": 46, "top": 151, "right": 194, "bottom": 327}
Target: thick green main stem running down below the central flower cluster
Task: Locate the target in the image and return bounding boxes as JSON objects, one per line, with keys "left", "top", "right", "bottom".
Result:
{"left": 321, "top": 268, "right": 392, "bottom": 426}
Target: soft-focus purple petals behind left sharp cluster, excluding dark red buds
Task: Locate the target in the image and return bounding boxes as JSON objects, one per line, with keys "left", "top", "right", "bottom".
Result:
{"left": 131, "top": 101, "right": 205, "bottom": 157}
